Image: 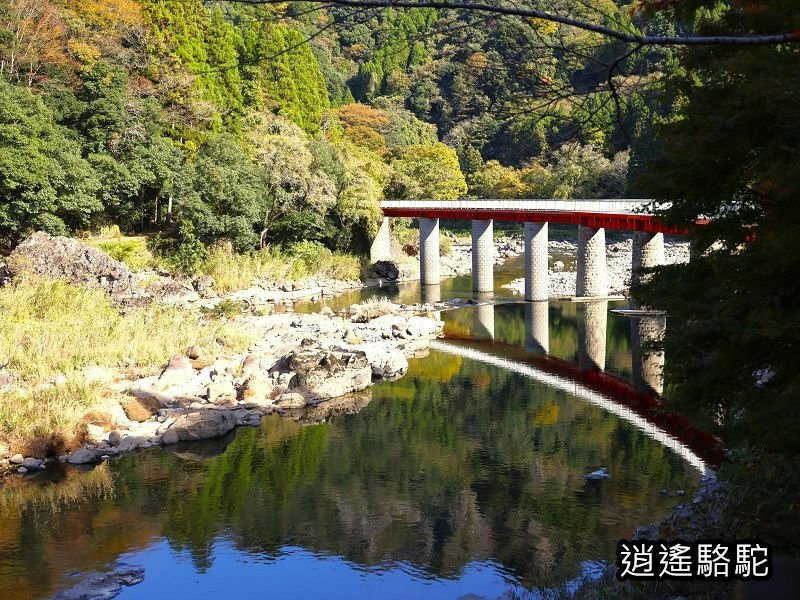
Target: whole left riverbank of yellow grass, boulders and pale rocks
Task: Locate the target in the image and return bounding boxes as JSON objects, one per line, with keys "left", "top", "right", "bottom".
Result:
{"left": 0, "top": 234, "right": 454, "bottom": 474}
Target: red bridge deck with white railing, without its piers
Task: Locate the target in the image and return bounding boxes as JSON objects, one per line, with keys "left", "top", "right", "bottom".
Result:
{"left": 381, "top": 199, "right": 686, "bottom": 234}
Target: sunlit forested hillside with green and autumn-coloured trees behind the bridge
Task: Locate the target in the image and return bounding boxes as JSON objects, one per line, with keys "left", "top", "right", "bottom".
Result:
{"left": 0, "top": 0, "right": 670, "bottom": 257}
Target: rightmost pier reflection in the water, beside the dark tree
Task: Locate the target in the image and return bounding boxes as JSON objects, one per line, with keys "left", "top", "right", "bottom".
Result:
{"left": 631, "top": 315, "right": 667, "bottom": 396}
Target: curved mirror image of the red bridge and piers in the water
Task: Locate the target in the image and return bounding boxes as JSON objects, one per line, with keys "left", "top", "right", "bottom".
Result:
{"left": 440, "top": 294, "right": 721, "bottom": 475}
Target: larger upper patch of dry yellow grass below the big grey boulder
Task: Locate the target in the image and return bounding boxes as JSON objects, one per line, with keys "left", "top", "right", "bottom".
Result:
{"left": 0, "top": 281, "right": 249, "bottom": 383}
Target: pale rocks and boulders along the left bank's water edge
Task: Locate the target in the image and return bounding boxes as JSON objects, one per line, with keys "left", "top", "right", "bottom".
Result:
{"left": 3, "top": 301, "right": 442, "bottom": 474}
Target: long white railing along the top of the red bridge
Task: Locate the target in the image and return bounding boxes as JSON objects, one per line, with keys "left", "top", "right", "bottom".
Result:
{"left": 381, "top": 198, "right": 652, "bottom": 214}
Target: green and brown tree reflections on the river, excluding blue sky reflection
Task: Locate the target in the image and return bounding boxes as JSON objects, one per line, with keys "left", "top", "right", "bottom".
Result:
{"left": 0, "top": 352, "right": 693, "bottom": 592}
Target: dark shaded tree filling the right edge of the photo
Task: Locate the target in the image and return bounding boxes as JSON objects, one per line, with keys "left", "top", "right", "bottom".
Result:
{"left": 636, "top": 0, "right": 800, "bottom": 551}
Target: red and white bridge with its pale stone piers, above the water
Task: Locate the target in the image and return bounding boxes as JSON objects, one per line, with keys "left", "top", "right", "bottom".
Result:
{"left": 370, "top": 199, "right": 686, "bottom": 300}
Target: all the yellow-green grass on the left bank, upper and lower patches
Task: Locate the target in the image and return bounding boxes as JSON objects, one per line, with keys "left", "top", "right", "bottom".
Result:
{"left": 0, "top": 280, "right": 252, "bottom": 449}
